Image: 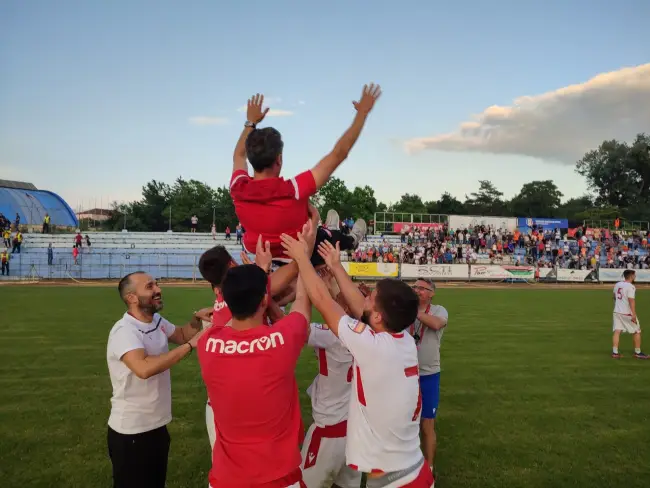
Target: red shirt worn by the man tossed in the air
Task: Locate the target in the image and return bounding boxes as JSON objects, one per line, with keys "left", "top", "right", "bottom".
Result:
{"left": 230, "top": 170, "right": 317, "bottom": 258}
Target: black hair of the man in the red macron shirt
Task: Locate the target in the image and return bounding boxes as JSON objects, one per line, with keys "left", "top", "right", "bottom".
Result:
{"left": 221, "top": 264, "right": 267, "bottom": 320}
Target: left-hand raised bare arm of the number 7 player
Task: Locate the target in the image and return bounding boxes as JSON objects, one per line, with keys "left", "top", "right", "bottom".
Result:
{"left": 281, "top": 229, "right": 345, "bottom": 336}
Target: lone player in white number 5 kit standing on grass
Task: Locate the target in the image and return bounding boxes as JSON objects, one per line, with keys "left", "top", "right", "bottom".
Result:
{"left": 612, "top": 269, "right": 650, "bottom": 359}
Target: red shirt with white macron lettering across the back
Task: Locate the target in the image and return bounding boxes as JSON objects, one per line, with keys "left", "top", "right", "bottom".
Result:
{"left": 196, "top": 312, "right": 308, "bottom": 488}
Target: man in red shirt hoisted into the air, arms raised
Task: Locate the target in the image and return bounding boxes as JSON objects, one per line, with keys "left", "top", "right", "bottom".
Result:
{"left": 230, "top": 84, "right": 381, "bottom": 258}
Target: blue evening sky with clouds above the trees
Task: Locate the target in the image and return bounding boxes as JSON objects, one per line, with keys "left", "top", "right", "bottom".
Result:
{"left": 0, "top": 0, "right": 650, "bottom": 213}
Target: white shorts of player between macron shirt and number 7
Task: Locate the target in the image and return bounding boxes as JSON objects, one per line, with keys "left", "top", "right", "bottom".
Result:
{"left": 301, "top": 424, "right": 361, "bottom": 488}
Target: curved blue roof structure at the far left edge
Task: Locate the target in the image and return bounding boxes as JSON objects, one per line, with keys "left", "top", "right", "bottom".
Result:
{"left": 0, "top": 180, "right": 79, "bottom": 227}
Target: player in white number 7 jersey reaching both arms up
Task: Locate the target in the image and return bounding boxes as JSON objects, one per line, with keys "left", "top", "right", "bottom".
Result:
{"left": 282, "top": 235, "right": 434, "bottom": 488}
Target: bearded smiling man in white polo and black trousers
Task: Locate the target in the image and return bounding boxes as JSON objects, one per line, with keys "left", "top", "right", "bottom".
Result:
{"left": 106, "top": 272, "right": 212, "bottom": 488}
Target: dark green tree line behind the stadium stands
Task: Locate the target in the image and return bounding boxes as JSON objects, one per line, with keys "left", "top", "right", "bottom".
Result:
{"left": 102, "top": 134, "right": 650, "bottom": 232}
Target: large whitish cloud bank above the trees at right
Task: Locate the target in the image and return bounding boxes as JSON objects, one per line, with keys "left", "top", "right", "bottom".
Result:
{"left": 405, "top": 64, "right": 650, "bottom": 164}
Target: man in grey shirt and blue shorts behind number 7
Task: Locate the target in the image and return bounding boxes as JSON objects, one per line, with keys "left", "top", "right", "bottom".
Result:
{"left": 409, "top": 279, "right": 449, "bottom": 470}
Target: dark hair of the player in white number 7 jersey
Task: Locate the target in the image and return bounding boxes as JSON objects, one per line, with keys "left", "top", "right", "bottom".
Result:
{"left": 375, "top": 278, "right": 419, "bottom": 334}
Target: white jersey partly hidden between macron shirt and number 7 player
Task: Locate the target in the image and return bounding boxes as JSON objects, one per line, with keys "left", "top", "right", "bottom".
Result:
{"left": 307, "top": 324, "right": 352, "bottom": 427}
